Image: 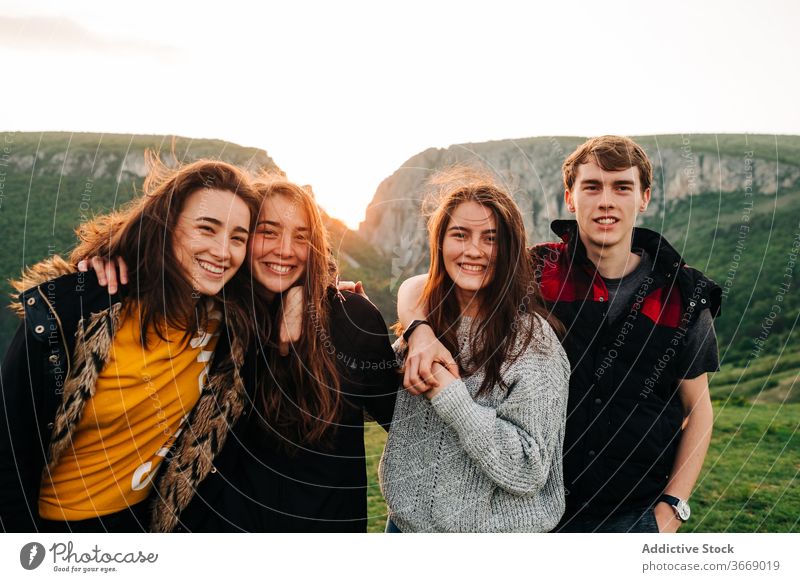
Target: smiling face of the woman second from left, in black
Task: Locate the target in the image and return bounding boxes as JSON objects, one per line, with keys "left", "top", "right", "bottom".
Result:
{"left": 250, "top": 195, "right": 310, "bottom": 295}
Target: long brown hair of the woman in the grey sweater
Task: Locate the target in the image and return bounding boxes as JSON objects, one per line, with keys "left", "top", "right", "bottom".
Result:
{"left": 420, "top": 166, "right": 561, "bottom": 394}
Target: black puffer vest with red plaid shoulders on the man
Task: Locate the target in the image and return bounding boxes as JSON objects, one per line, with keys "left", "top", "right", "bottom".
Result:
{"left": 533, "top": 220, "right": 721, "bottom": 517}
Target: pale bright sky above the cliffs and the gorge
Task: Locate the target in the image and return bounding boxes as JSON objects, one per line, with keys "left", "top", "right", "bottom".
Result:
{"left": 0, "top": 0, "right": 800, "bottom": 227}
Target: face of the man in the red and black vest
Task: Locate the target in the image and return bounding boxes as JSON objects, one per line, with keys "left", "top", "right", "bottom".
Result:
{"left": 564, "top": 162, "right": 650, "bottom": 257}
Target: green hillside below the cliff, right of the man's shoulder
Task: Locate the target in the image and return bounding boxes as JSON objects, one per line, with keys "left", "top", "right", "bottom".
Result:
{"left": 644, "top": 190, "right": 800, "bottom": 388}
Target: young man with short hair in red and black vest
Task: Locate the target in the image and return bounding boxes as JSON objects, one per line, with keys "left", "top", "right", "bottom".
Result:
{"left": 398, "top": 136, "right": 721, "bottom": 532}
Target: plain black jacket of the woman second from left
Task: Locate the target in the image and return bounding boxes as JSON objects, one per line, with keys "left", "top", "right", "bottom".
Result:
{"left": 181, "top": 293, "right": 400, "bottom": 532}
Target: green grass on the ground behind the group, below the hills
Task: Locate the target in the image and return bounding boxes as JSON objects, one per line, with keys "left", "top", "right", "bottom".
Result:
{"left": 365, "top": 401, "right": 800, "bottom": 533}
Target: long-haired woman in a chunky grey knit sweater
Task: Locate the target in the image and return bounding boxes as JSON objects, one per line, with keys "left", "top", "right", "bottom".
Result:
{"left": 380, "top": 168, "right": 569, "bottom": 532}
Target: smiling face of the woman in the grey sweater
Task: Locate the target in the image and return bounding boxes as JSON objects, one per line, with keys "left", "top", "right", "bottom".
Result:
{"left": 442, "top": 202, "right": 497, "bottom": 313}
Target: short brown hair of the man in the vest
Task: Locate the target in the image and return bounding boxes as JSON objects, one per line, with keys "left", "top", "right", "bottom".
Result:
{"left": 561, "top": 135, "right": 653, "bottom": 192}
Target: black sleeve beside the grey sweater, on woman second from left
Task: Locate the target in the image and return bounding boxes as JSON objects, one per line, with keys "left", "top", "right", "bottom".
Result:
{"left": 331, "top": 293, "right": 400, "bottom": 430}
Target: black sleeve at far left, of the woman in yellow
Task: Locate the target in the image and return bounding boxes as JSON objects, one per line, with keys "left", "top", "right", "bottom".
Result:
{"left": 0, "top": 322, "right": 44, "bottom": 532}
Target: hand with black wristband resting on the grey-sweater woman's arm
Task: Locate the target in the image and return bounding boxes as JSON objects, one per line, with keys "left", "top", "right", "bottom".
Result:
{"left": 403, "top": 325, "right": 459, "bottom": 396}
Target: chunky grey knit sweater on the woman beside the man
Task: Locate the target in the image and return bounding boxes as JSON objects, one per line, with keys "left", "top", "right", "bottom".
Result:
{"left": 380, "top": 315, "right": 570, "bottom": 532}
